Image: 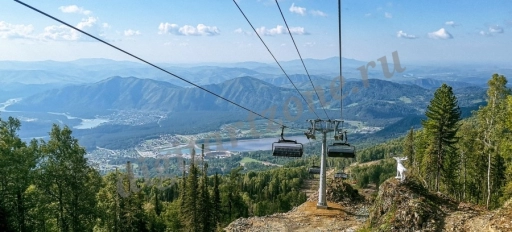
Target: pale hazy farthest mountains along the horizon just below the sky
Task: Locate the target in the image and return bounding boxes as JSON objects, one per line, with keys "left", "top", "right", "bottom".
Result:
{"left": 0, "top": 57, "right": 506, "bottom": 93}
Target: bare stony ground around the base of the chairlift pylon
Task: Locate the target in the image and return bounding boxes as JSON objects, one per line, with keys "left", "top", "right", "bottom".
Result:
{"left": 225, "top": 180, "right": 368, "bottom": 232}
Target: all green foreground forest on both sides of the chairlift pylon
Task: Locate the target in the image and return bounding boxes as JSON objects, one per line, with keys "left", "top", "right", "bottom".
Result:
{"left": 0, "top": 74, "right": 512, "bottom": 231}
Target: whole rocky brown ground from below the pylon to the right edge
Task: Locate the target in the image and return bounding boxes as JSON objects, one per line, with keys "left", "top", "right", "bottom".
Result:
{"left": 225, "top": 178, "right": 512, "bottom": 232}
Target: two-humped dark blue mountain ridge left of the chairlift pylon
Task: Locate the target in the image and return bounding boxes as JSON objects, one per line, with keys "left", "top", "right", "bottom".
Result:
{"left": 9, "top": 77, "right": 300, "bottom": 112}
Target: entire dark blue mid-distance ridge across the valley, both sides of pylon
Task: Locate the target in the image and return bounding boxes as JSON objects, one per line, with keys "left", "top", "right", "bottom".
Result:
{"left": 7, "top": 76, "right": 484, "bottom": 125}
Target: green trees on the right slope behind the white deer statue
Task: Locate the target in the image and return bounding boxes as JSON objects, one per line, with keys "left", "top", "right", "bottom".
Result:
{"left": 353, "top": 74, "right": 512, "bottom": 209}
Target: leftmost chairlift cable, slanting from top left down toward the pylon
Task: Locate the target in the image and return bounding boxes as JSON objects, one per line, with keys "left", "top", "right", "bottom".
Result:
{"left": 14, "top": 0, "right": 284, "bottom": 126}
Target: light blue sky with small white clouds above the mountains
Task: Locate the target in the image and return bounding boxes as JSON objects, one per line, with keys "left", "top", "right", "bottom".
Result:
{"left": 0, "top": 0, "right": 512, "bottom": 66}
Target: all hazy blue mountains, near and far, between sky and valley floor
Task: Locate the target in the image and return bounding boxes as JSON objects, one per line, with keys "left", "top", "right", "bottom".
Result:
{"left": 0, "top": 58, "right": 498, "bottom": 149}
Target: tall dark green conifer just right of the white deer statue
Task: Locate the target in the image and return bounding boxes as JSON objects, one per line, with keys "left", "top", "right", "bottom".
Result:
{"left": 422, "top": 84, "right": 461, "bottom": 192}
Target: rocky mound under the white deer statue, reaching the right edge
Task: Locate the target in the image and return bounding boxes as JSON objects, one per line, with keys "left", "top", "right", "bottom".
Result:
{"left": 368, "top": 179, "right": 512, "bottom": 232}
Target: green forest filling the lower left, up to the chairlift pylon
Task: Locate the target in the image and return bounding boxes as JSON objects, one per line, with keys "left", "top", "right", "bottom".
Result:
{"left": 0, "top": 118, "right": 308, "bottom": 231}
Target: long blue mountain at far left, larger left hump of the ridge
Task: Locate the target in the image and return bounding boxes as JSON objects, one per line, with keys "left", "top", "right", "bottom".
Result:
{"left": 7, "top": 77, "right": 181, "bottom": 112}
